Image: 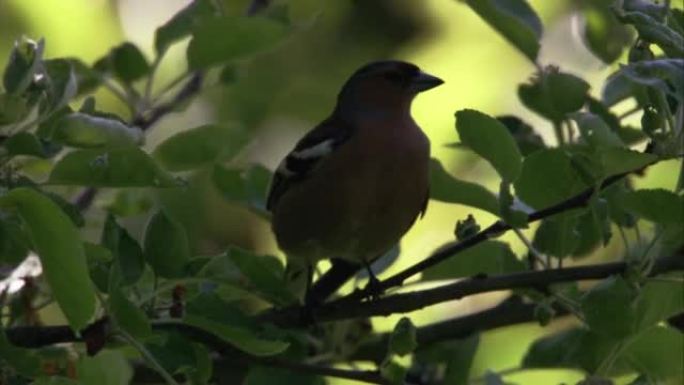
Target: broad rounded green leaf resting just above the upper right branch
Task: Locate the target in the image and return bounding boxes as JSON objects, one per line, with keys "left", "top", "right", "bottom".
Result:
{"left": 514, "top": 149, "right": 585, "bottom": 209}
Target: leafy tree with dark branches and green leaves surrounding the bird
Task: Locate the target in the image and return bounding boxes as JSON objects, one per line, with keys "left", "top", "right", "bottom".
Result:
{"left": 0, "top": 0, "right": 684, "bottom": 385}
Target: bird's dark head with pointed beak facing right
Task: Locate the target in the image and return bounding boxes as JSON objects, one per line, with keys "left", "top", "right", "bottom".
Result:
{"left": 337, "top": 60, "right": 444, "bottom": 113}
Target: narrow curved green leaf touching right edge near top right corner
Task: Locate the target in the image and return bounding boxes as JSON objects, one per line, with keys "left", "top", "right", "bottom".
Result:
{"left": 619, "top": 12, "right": 684, "bottom": 57}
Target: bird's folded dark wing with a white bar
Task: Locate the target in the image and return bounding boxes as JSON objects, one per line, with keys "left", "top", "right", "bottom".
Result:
{"left": 266, "top": 116, "right": 353, "bottom": 211}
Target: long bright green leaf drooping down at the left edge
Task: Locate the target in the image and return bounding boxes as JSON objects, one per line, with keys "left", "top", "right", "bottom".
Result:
{"left": 0, "top": 187, "right": 95, "bottom": 330}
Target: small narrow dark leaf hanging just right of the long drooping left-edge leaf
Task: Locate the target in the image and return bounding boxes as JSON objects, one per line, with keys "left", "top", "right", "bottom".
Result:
{"left": 101, "top": 214, "right": 145, "bottom": 285}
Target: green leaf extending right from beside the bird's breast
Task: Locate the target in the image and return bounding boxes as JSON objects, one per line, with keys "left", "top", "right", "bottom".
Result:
{"left": 430, "top": 158, "right": 499, "bottom": 215}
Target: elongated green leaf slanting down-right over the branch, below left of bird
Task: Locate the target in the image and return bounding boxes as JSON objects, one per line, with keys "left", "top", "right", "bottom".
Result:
{"left": 183, "top": 294, "right": 290, "bottom": 357}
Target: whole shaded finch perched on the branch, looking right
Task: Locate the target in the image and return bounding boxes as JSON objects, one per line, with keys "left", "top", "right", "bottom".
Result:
{"left": 266, "top": 60, "right": 444, "bottom": 303}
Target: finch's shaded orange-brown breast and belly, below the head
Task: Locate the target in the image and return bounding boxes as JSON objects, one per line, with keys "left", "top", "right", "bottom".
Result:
{"left": 273, "top": 119, "right": 430, "bottom": 263}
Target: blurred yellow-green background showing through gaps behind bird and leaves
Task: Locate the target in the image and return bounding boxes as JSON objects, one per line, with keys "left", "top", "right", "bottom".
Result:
{"left": 0, "top": 0, "right": 676, "bottom": 384}
